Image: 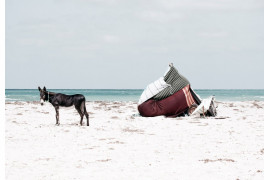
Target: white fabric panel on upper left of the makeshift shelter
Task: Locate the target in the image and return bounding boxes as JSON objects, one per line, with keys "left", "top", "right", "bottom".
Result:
{"left": 138, "top": 77, "right": 170, "bottom": 105}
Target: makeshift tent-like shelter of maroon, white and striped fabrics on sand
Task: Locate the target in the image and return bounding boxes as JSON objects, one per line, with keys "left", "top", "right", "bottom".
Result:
{"left": 138, "top": 64, "right": 215, "bottom": 117}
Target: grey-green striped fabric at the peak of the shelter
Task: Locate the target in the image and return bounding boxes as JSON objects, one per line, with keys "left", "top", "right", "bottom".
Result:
{"left": 153, "top": 66, "right": 189, "bottom": 100}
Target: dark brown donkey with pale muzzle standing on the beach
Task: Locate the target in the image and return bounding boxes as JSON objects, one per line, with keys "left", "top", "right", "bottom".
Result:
{"left": 38, "top": 86, "right": 89, "bottom": 126}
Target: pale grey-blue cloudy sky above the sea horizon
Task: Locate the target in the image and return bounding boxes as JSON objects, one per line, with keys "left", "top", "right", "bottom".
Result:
{"left": 5, "top": 0, "right": 264, "bottom": 89}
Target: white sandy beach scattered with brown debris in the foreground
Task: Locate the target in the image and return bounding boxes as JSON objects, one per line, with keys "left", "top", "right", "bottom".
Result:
{"left": 5, "top": 101, "right": 264, "bottom": 180}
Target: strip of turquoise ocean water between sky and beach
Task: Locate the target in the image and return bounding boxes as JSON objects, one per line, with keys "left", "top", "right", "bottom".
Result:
{"left": 5, "top": 89, "right": 264, "bottom": 102}
